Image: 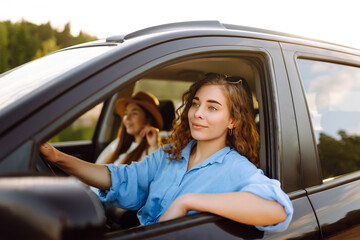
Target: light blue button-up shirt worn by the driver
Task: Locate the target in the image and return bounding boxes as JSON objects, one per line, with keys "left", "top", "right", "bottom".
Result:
{"left": 99, "top": 140, "right": 293, "bottom": 231}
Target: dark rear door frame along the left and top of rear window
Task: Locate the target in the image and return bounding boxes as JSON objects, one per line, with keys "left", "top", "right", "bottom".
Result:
{"left": 281, "top": 43, "right": 360, "bottom": 188}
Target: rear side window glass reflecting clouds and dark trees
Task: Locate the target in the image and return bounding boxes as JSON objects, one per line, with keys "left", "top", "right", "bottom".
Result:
{"left": 298, "top": 59, "right": 360, "bottom": 181}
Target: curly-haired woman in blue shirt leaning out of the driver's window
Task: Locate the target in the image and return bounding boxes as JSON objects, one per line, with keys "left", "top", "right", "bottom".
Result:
{"left": 41, "top": 73, "right": 293, "bottom": 231}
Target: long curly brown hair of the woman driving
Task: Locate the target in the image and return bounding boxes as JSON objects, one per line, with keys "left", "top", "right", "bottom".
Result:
{"left": 162, "top": 73, "right": 259, "bottom": 167}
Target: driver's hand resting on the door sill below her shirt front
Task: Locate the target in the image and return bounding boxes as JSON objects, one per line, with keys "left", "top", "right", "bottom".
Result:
{"left": 159, "top": 194, "right": 191, "bottom": 222}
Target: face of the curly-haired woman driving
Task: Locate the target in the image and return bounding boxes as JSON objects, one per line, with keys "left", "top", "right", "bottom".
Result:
{"left": 188, "top": 85, "right": 233, "bottom": 143}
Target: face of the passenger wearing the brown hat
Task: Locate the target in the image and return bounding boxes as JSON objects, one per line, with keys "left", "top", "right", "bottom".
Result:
{"left": 123, "top": 103, "right": 147, "bottom": 137}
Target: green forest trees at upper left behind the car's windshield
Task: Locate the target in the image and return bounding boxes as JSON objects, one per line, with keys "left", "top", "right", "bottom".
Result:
{"left": 0, "top": 20, "right": 97, "bottom": 73}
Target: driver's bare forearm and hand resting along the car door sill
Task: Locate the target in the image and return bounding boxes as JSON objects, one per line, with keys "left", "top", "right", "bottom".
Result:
{"left": 159, "top": 192, "right": 287, "bottom": 225}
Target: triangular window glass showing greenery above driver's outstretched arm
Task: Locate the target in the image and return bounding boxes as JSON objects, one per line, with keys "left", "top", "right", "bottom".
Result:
{"left": 49, "top": 103, "right": 103, "bottom": 143}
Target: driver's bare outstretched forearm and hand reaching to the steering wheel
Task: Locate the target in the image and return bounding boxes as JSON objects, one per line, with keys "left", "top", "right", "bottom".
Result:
{"left": 40, "top": 143, "right": 111, "bottom": 190}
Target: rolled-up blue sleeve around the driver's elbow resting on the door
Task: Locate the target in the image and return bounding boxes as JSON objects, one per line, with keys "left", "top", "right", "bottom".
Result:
{"left": 241, "top": 170, "right": 294, "bottom": 232}
